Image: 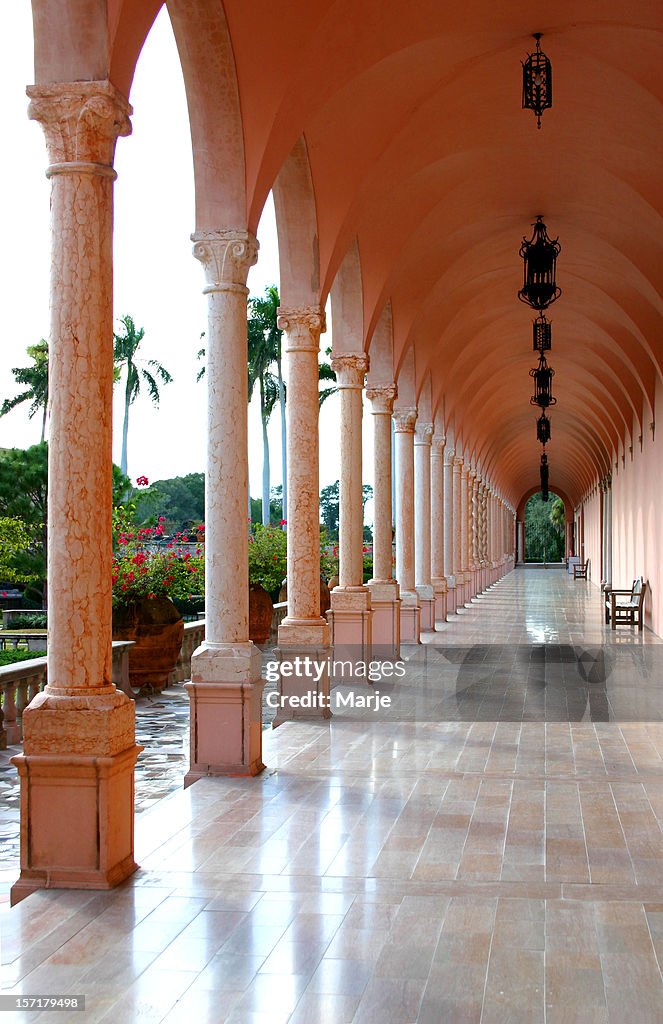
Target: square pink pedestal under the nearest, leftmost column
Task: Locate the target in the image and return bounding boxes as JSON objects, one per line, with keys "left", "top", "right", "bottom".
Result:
{"left": 10, "top": 744, "right": 142, "bottom": 906}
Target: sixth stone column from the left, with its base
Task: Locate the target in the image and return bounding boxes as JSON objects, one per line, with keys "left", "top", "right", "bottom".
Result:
{"left": 393, "top": 409, "right": 420, "bottom": 643}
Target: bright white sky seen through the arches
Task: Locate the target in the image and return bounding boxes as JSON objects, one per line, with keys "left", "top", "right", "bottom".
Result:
{"left": 0, "top": 8, "right": 372, "bottom": 519}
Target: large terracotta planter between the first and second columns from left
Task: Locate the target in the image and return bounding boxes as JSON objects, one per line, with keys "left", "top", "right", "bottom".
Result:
{"left": 113, "top": 597, "right": 184, "bottom": 692}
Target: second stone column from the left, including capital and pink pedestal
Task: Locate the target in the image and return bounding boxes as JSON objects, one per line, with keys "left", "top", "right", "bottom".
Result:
{"left": 184, "top": 230, "right": 263, "bottom": 785}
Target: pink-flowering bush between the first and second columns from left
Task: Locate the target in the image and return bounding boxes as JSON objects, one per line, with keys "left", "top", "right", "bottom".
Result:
{"left": 113, "top": 507, "right": 205, "bottom": 607}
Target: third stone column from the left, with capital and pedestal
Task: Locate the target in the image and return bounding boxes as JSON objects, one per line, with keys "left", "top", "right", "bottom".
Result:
{"left": 274, "top": 306, "right": 331, "bottom": 726}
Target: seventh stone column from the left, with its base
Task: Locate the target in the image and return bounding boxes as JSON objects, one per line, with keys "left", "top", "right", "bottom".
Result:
{"left": 414, "top": 420, "right": 436, "bottom": 633}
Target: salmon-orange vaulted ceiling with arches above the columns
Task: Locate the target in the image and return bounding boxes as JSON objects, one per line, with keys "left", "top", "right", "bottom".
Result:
{"left": 36, "top": 0, "right": 663, "bottom": 504}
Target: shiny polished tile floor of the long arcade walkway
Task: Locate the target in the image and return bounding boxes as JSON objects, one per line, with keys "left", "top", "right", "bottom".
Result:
{"left": 0, "top": 569, "right": 663, "bottom": 1024}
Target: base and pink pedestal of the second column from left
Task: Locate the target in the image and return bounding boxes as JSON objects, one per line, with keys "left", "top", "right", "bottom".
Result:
{"left": 184, "top": 641, "right": 264, "bottom": 788}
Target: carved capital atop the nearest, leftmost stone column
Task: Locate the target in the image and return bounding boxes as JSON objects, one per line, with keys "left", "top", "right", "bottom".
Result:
{"left": 27, "top": 81, "right": 132, "bottom": 177}
